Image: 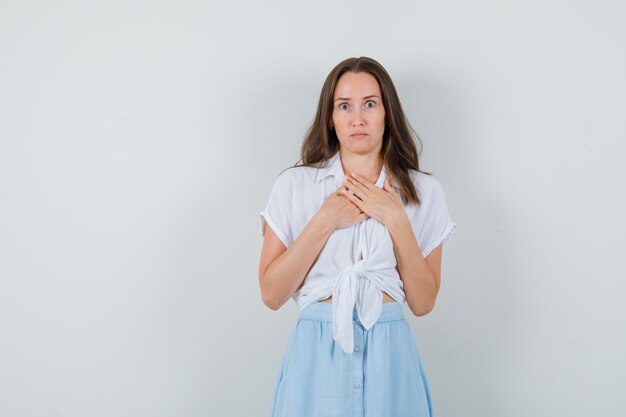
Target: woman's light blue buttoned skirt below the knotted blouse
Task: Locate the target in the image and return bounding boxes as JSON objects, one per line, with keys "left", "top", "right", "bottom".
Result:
{"left": 270, "top": 302, "right": 433, "bottom": 417}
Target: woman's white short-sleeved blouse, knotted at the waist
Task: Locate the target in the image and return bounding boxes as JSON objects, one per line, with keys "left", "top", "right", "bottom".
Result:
{"left": 259, "top": 152, "right": 456, "bottom": 353}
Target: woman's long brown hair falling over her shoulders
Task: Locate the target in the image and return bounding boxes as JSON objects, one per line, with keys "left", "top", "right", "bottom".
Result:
{"left": 295, "top": 57, "right": 431, "bottom": 205}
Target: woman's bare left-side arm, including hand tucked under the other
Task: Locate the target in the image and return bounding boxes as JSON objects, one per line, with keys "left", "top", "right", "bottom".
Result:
{"left": 259, "top": 187, "right": 367, "bottom": 310}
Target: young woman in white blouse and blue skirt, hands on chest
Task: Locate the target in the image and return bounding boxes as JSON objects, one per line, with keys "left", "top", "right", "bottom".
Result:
{"left": 259, "top": 57, "right": 456, "bottom": 417}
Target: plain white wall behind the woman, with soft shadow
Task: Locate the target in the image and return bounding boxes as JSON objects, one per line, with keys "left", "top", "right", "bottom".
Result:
{"left": 0, "top": 0, "right": 626, "bottom": 417}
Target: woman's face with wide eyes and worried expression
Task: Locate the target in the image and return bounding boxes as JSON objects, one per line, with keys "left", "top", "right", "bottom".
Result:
{"left": 332, "top": 72, "right": 385, "bottom": 155}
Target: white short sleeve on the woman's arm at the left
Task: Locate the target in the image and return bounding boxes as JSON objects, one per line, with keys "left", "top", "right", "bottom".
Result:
{"left": 259, "top": 170, "right": 293, "bottom": 247}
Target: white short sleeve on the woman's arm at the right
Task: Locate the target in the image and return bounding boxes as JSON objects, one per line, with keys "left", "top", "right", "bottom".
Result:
{"left": 409, "top": 176, "right": 456, "bottom": 258}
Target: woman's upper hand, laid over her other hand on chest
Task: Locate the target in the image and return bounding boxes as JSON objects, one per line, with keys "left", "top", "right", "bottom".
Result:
{"left": 341, "top": 173, "right": 406, "bottom": 226}
